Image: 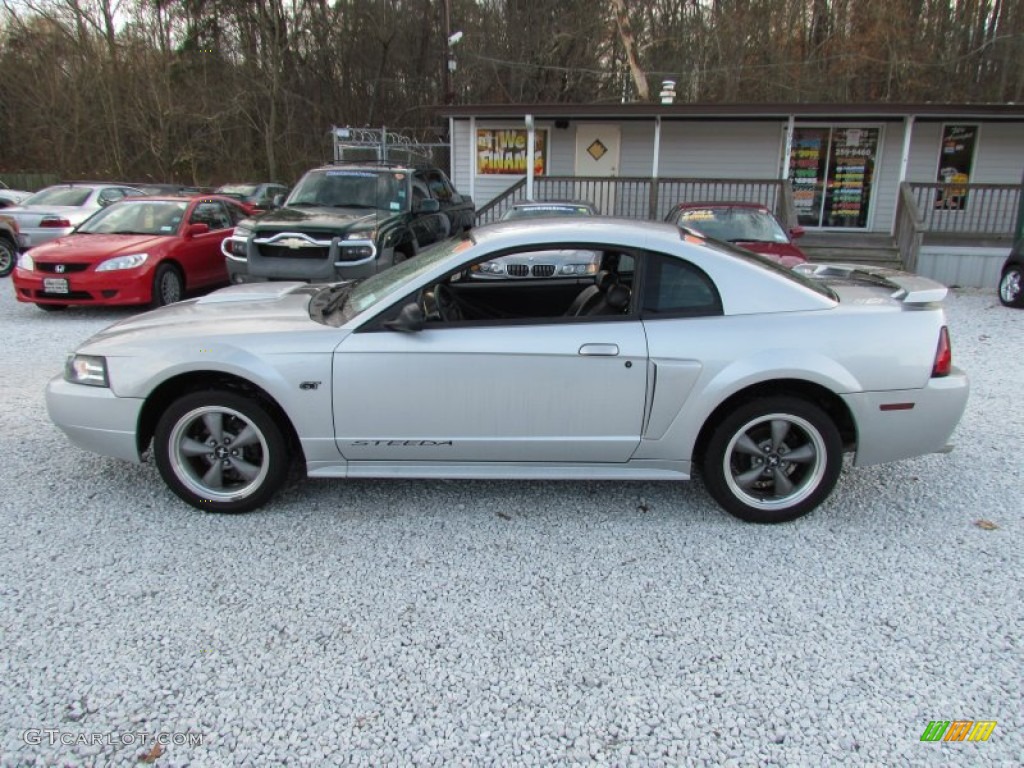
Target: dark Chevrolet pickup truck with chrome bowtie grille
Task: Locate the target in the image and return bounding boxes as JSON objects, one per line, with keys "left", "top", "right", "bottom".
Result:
{"left": 221, "top": 163, "right": 476, "bottom": 283}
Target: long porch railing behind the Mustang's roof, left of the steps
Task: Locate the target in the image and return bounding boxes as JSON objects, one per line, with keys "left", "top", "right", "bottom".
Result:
{"left": 476, "top": 176, "right": 797, "bottom": 226}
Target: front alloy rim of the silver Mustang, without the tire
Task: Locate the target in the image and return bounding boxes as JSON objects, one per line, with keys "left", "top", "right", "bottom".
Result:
{"left": 168, "top": 406, "right": 269, "bottom": 502}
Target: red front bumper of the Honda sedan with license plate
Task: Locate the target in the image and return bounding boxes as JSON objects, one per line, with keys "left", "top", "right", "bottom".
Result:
{"left": 12, "top": 267, "right": 153, "bottom": 305}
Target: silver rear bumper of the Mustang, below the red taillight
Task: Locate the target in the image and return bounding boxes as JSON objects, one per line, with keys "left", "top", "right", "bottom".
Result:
{"left": 843, "top": 368, "right": 970, "bottom": 467}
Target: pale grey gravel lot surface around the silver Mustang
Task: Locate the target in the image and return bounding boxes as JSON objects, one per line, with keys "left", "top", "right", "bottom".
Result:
{"left": 0, "top": 280, "right": 1024, "bottom": 768}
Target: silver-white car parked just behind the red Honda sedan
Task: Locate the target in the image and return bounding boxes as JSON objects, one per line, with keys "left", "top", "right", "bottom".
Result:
{"left": 3, "top": 182, "right": 142, "bottom": 249}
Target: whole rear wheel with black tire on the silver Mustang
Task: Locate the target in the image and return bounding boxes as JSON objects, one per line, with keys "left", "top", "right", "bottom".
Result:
{"left": 703, "top": 396, "right": 843, "bottom": 523}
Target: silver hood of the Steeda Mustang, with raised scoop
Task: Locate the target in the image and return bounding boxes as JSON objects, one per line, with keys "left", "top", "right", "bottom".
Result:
{"left": 79, "top": 283, "right": 346, "bottom": 355}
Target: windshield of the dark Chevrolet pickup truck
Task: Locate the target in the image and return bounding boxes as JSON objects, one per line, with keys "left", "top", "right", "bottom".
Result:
{"left": 286, "top": 169, "right": 409, "bottom": 211}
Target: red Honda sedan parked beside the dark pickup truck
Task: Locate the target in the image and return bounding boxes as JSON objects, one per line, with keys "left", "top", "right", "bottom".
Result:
{"left": 13, "top": 196, "right": 246, "bottom": 310}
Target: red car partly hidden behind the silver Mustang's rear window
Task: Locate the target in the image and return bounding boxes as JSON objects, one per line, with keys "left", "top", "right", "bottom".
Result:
{"left": 666, "top": 203, "right": 807, "bottom": 266}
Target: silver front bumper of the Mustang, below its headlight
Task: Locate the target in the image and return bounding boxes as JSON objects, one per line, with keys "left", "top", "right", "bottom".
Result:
{"left": 46, "top": 376, "right": 143, "bottom": 463}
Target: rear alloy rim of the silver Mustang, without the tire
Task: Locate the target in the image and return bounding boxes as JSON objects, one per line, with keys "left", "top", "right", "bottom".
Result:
{"left": 722, "top": 414, "right": 826, "bottom": 511}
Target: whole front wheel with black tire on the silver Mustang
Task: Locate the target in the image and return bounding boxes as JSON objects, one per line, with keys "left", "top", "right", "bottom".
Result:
{"left": 154, "top": 390, "right": 291, "bottom": 512}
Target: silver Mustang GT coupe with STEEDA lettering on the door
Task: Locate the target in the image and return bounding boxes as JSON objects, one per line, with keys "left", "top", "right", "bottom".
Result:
{"left": 47, "top": 217, "right": 968, "bottom": 522}
